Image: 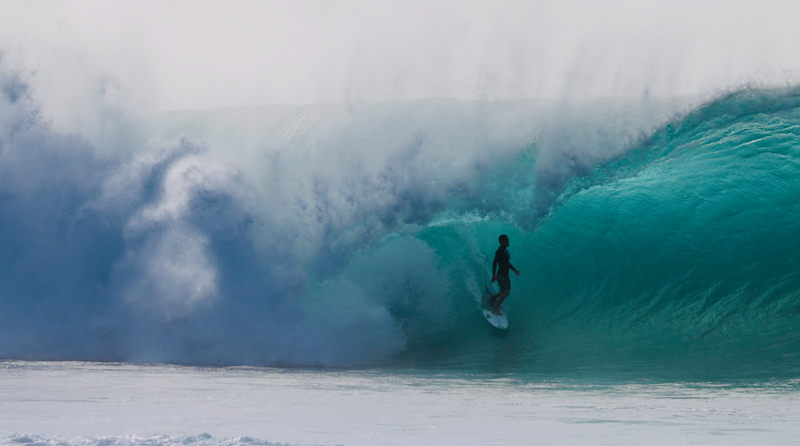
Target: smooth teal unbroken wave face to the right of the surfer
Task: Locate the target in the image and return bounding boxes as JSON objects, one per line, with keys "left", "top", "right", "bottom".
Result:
{"left": 400, "top": 86, "right": 800, "bottom": 376}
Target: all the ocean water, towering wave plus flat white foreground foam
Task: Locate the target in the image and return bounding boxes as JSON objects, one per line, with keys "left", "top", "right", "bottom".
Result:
{"left": 0, "top": 59, "right": 800, "bottom": 445}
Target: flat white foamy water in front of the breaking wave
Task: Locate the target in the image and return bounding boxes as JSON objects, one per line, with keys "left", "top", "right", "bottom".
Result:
{"left": 0, "top": 361, "right": 800, "bottom": 446}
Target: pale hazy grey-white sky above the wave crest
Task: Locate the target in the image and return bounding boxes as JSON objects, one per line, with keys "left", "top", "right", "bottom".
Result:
{"left": 0, "top": 0, "right": 800, "bottom": 110}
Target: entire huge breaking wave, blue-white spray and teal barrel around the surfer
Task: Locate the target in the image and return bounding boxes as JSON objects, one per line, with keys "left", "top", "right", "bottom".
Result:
{"left": 0, "top": 57, "right": 800, "bottom": 374}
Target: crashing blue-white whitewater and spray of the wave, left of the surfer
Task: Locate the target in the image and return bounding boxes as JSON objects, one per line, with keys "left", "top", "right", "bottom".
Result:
{"left": 0, "top": 58, "right": 692, "bottom": 365}
